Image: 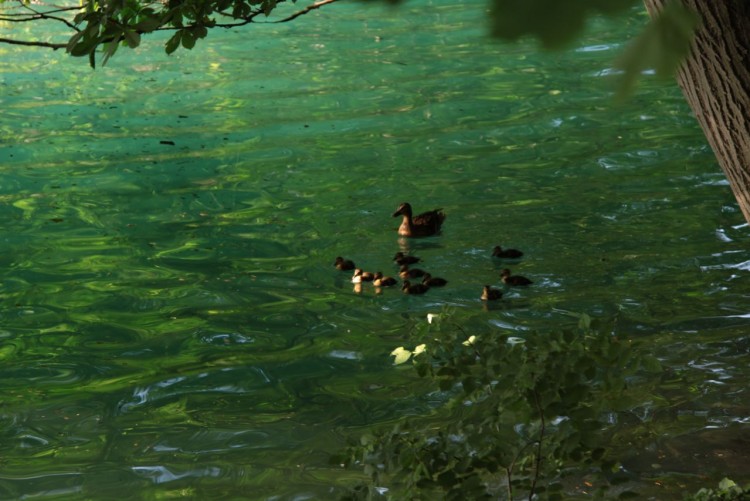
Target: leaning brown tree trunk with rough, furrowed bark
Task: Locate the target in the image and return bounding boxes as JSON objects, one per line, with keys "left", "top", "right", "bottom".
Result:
{"left": 644, "top": 0, "right": 750, "bottom": 223}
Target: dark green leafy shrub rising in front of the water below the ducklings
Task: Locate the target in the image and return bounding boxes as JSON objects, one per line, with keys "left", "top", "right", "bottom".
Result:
{"left": 348, "top": 315, "right": 659, "bottom": 499}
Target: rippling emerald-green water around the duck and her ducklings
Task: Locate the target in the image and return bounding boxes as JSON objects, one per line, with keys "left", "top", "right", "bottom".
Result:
{"left": 0, "top": 1, "right": 750, "bottom": 499}
